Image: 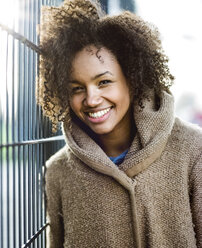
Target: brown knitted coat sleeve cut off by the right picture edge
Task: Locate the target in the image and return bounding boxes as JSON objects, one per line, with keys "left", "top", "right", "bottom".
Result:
{"left": 191, "top": 156, "right": 202, "bottom": 248}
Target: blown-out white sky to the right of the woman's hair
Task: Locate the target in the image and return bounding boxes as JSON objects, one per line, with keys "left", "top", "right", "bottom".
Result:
{"left": 136, "top": 0, "right": 202, "bottom": 117}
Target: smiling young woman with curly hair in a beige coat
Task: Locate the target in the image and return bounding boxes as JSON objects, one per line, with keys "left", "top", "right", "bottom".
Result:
{"left": 38, "top": 0, "right": 202, "bottom": 248}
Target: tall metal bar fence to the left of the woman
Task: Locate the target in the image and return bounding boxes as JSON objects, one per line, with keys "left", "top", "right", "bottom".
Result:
{"left": 0, "top": 0, "right": 64, "bottom": 248}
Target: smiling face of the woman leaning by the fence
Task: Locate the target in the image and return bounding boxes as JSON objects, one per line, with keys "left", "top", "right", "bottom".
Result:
{"left": 70, "top": 46, "right": 130, "bottom": 135}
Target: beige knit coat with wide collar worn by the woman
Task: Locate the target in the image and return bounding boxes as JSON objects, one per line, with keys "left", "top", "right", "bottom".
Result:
{"left": 46, "top": 92, "right": 202, "bottom": 248}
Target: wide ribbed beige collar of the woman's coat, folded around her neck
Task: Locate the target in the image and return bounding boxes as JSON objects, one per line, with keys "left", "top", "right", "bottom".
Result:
{"left": 63, "top": 92, "right": 174, "bottom": 185}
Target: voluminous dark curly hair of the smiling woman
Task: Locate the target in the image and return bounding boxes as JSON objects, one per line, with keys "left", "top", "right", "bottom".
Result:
{"left": 37, "top": 0, "right": 174, "bottom": 132}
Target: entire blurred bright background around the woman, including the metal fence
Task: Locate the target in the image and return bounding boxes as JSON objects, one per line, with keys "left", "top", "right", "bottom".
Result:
{"left": 0, "top": 0, "right": 202, "bottom": 248}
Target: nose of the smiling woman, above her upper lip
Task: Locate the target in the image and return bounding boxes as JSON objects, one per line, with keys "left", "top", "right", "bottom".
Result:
{"left": 84, "top": 89, "right": 102, "bottom": 107}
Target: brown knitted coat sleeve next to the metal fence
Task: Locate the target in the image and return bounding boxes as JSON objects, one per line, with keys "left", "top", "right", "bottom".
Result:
{"left": 45, "top": 164, "right": 64, "bottom": 248}
